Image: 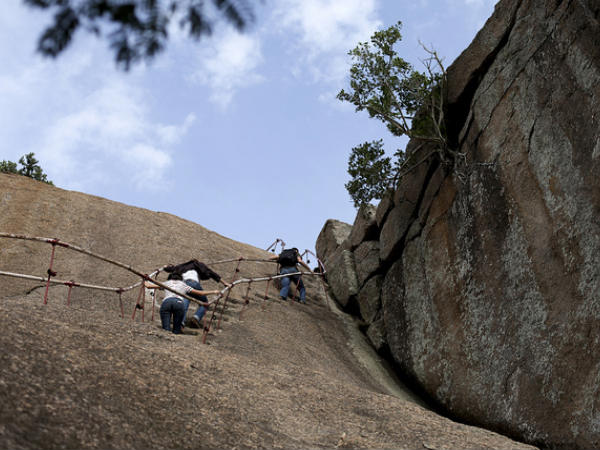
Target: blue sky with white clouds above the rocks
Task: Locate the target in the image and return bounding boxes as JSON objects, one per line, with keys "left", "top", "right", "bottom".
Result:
{"left": 0, "top": 0, "right": 496, "bottom": 257}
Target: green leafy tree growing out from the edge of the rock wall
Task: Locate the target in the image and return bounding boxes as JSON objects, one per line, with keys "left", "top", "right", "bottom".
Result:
{"left": 337, "top": 22, "right": 446, "bottom": 207}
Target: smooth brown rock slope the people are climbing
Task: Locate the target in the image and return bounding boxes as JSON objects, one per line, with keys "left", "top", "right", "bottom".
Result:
{"left": 0, "top": 174, "right": 531, "bottom": 449}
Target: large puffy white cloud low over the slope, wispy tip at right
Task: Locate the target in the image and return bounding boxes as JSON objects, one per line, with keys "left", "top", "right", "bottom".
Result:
{"left": 34, "top": 79, "right": 195, "bottom": 190}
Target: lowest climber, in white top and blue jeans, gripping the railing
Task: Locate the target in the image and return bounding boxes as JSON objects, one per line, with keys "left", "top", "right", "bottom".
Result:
{"left": 144, "top": 273, "right": 220, "bottom": 334}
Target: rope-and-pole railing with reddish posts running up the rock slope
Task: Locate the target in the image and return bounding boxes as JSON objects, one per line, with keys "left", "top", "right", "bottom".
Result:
{"left": 0, "top": 232, "right": 325, "bottom": 343}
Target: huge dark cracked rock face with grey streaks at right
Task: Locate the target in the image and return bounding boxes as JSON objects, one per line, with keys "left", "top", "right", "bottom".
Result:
{"left": 316, "top": 0, "right": 600, "bottom": 449}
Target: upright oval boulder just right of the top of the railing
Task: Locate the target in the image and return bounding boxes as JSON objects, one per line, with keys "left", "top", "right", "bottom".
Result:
{"left": 326, "top": 248, "right": 358, "bottom": 308}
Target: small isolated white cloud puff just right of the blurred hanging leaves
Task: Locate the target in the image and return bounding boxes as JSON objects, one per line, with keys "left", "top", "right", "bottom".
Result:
{"left": 189, "top": 28, "right": 264, "bottom": 109}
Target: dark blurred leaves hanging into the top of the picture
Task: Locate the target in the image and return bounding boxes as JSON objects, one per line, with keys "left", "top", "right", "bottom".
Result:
{"left": 23, "top": 0, "right": 254, "bottom": 70}
